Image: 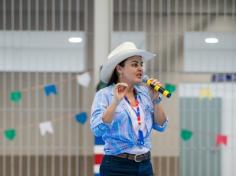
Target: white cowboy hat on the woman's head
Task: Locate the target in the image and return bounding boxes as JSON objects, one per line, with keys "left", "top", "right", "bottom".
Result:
{"left": 100, "top": 42, "right": 156, "bottom": 83}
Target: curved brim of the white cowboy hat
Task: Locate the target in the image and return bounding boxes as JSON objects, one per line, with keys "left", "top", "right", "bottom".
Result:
{"left": 100, "top": 49, "right": 156, "bottom": 83}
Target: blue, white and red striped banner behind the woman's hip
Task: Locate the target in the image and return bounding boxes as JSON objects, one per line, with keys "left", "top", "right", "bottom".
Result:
{"left": 93, "top": 137, "right": 105, "bottom": 176}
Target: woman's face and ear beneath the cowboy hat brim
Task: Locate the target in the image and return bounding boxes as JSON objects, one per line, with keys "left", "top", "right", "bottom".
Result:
{"left": 117, "top": 56, "right": 143, "bottom": 85}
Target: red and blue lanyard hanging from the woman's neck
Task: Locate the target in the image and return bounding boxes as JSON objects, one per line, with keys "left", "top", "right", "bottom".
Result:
{"left": 125, "top": 90, "right": 144, "bottom": 145}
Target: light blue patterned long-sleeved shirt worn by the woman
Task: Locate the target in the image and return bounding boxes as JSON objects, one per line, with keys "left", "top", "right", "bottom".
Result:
{"left": 90, "top": 84, "right": 168, "bottom": 155}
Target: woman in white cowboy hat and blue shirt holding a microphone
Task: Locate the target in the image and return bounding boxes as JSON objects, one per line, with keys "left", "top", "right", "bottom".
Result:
{"left": 90, "top": 42, "right": 167, "bottom": 176}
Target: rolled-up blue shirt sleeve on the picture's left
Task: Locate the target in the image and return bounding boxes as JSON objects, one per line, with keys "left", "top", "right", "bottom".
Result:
{"left": 90, "top": 91, "right": 110, "bottom": 136}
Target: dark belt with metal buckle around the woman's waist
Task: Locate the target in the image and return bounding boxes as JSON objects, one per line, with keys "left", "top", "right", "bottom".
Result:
{"left": 116, "top": 151, "right": 151, "bottom": 162}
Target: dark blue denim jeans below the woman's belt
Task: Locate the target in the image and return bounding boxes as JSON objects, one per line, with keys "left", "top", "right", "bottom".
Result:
{"left": 100, "top": 155, "right": 153, "bottom": 176}
